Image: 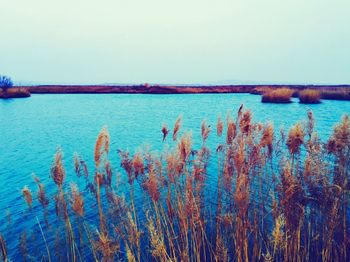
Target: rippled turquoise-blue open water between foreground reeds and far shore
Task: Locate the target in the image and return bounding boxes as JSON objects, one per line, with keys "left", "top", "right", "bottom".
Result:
{"left": 0, "top": 94, "right": 350, "bottom": 254}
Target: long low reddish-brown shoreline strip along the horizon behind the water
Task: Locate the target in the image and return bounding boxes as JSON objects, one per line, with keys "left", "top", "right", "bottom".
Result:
{"left": 21, "top": 84, "right": 350, "bottom": 94}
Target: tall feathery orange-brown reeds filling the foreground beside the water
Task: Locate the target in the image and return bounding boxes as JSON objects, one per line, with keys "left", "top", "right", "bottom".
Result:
{"left": 0, "top": 107, "right": 350, "bottom": 261}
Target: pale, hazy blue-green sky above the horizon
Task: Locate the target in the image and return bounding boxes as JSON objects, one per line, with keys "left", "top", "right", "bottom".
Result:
{"left": 0, "top": 0, "right": 350, "bottom": 84}
